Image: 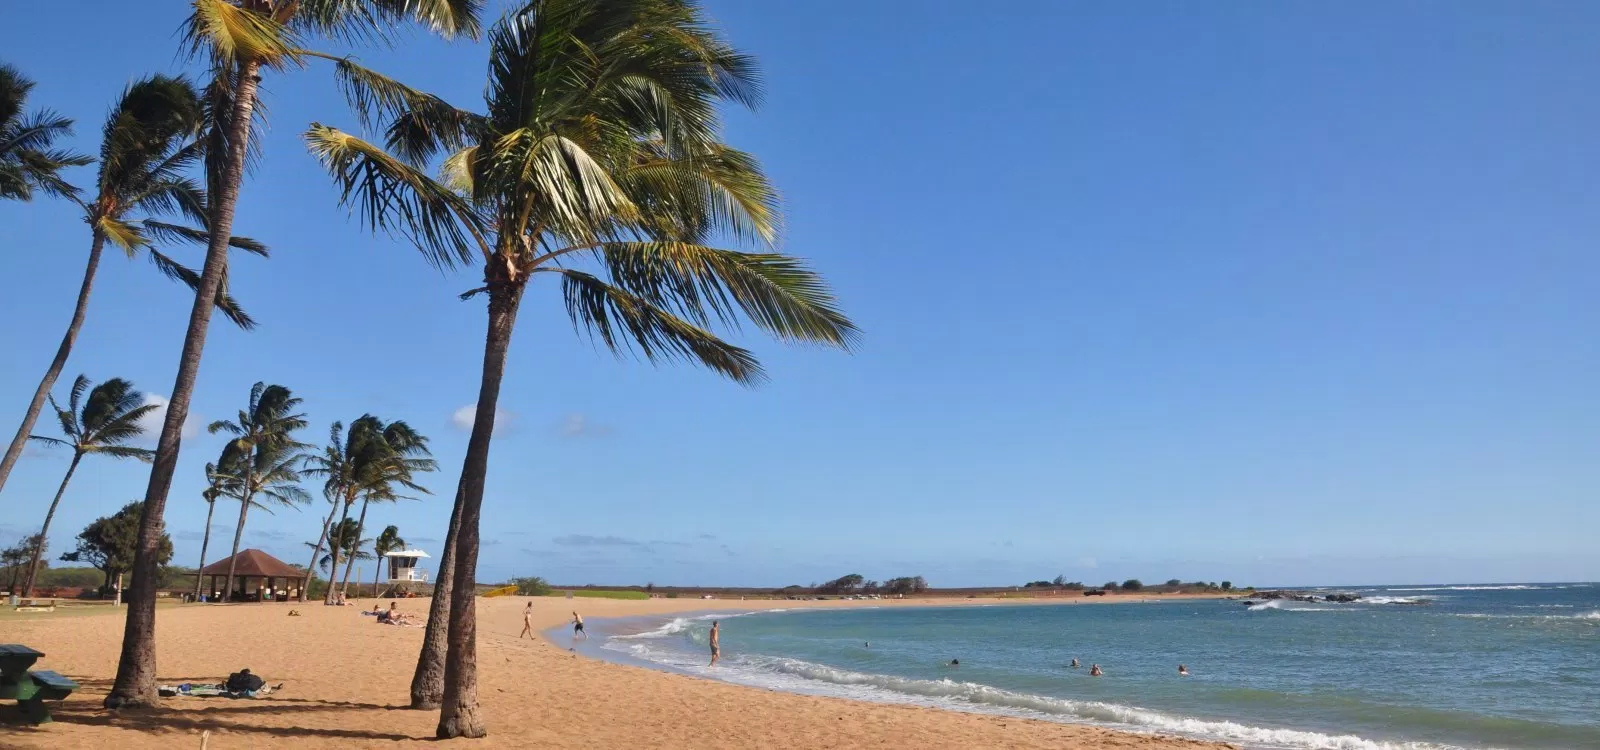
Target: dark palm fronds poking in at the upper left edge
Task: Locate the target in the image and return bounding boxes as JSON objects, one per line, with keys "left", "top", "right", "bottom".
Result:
{"left": 0, "top": 64, "right": 93, "bottom": 200}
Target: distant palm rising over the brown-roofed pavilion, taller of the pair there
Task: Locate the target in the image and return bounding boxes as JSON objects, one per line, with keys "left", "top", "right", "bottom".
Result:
{"left": 208, "top": 382, "right": 310, "bottom": 596}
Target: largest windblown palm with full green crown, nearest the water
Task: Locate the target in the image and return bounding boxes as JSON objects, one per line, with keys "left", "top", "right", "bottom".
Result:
{"left": 306, "top": 0, "right": 856, "bottom": 737}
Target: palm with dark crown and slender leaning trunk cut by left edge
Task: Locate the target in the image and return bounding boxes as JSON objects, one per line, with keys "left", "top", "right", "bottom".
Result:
{"left": 0, "top": 75, "right": 267, "bottom": 489}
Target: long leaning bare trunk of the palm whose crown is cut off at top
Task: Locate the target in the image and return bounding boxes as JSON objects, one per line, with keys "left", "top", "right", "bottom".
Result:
{"left": 106, "top": 61, "right": 261, "bottom": 708}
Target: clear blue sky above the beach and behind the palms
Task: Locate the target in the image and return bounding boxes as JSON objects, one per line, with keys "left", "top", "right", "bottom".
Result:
{"left": 0, "top": 0, "right": 1600, "bottom": 585}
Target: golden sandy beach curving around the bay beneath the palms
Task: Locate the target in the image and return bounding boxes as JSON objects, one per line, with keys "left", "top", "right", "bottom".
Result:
{"left": 0, "top": 596, "right": 1226, "bottom": 750}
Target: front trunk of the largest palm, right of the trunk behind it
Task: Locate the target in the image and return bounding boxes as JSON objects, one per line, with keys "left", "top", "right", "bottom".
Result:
{"left": 434, "top": 277, "right": 523, "bottom": 739}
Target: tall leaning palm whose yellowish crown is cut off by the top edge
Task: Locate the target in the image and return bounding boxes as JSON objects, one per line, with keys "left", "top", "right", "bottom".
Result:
{"left": 113, "top": 0, "right": 482, "bottom": 708}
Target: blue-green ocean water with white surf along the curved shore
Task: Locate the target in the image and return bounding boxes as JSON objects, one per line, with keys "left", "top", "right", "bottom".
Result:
{"left": 585, "top": 584, "right": 1600, "bottom": 750}
